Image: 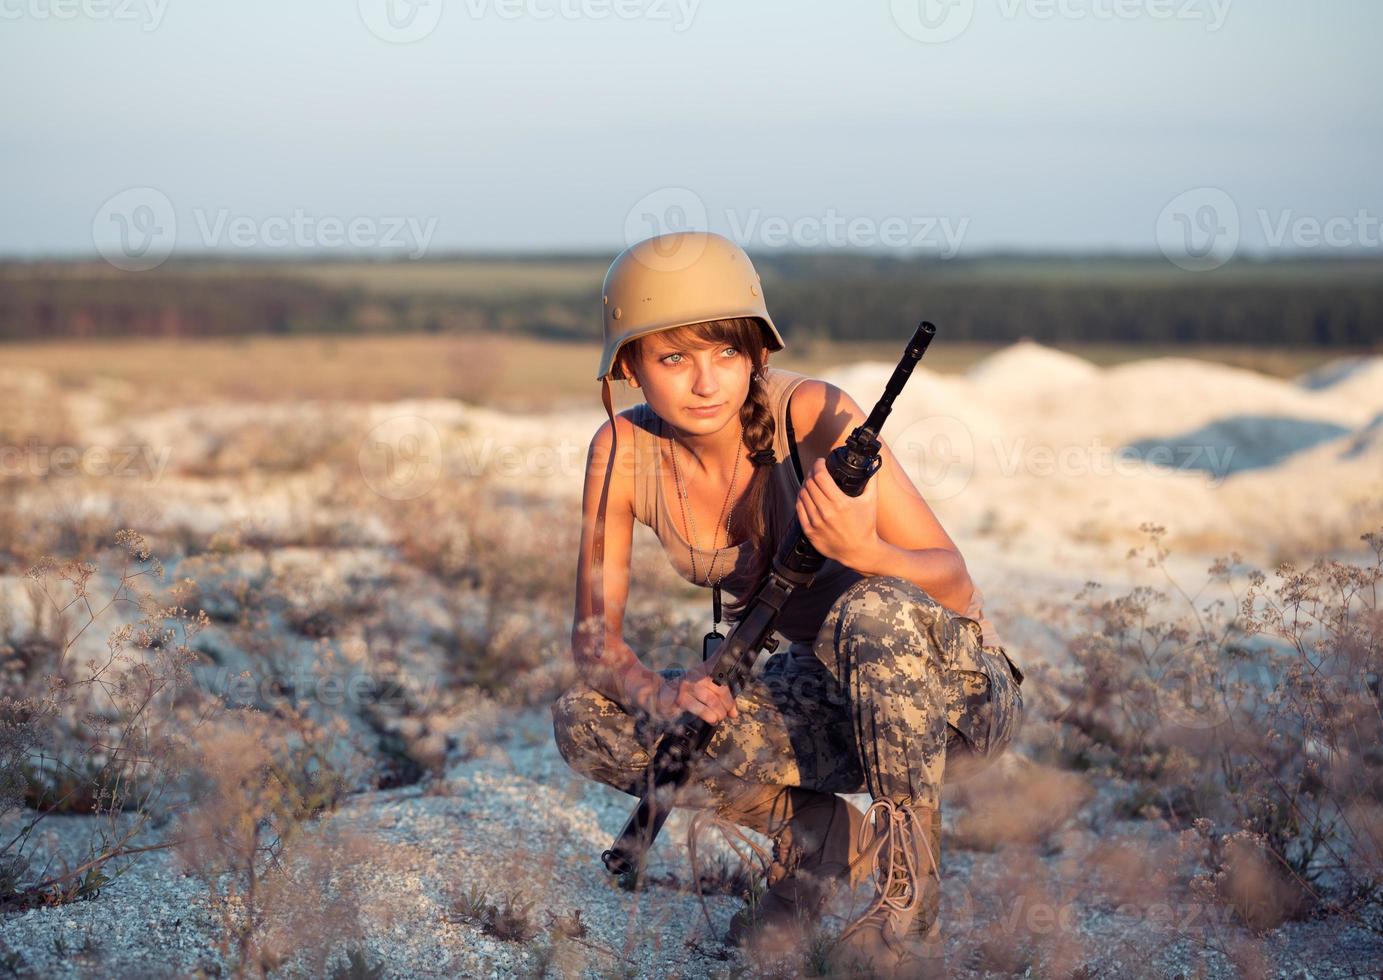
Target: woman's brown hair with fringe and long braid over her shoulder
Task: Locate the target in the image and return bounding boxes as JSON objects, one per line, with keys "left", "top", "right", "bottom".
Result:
{"left": 615, "top": 317, "right": 792, "bottom": 621}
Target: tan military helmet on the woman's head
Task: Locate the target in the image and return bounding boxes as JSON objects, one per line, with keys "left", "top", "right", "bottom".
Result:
{"left": 596, "top": 231, "right": 784, "bottom": 381}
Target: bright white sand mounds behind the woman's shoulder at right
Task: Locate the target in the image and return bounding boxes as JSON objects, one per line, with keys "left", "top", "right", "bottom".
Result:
{"left": 791, "top": 349, "right": 1383, "bottom": 567}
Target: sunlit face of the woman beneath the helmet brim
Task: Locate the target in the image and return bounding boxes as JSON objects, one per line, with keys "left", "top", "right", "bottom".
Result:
{"left": 629, "top": 330, "right": 768, "bottom": 435}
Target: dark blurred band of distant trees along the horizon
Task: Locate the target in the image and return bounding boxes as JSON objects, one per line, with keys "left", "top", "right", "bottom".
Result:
{"left": 0, "top": 256, "right": 1383, "bottom": 347}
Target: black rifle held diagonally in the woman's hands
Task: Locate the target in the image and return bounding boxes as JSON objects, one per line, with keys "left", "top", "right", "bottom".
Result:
{"left": 600, "top": 321, "right": 936, "bottom": 875}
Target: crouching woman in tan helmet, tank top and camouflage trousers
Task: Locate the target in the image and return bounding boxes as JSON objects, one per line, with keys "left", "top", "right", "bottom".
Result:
{"left": 553, "top": 232, "right": 1022, "bottom": 974}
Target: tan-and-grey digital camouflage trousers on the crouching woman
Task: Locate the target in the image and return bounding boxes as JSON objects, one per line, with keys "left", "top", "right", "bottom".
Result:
{"left": 552, "top": 576, "right": 1022, "bottom": 822}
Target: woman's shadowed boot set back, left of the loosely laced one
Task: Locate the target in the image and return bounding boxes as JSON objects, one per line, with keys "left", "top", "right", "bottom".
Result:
{"left": 722, "top": 786, "right": 864, "bottom": 950}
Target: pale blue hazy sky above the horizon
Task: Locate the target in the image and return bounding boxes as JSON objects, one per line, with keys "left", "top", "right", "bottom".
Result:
{"left": 0, "top": 0, "right": 1383, "bottom": 256}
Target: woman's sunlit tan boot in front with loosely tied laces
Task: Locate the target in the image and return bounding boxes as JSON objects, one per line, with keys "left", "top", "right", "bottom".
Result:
{"left": 831, "top": 796, "right": 945, "bottom": 977}
